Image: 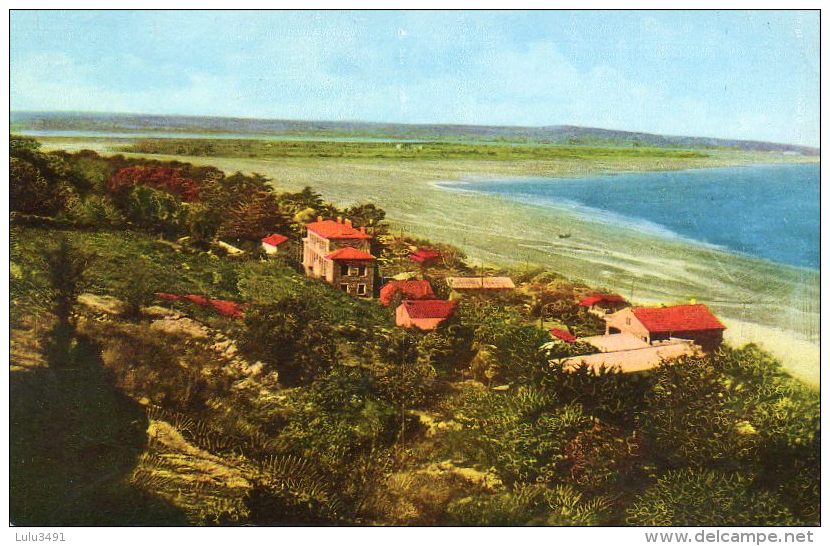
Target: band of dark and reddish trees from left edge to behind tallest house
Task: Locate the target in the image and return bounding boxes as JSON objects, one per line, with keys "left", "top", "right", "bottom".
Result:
{"left": 10, "top": 136, "right": 396, "bottom": 252}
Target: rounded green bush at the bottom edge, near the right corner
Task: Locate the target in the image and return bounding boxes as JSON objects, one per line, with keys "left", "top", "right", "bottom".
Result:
{"left": 626, "top": 469, "right": 796, "bottom": 527}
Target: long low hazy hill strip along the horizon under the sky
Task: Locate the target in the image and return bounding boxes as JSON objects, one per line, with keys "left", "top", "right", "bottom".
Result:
{"left": 11, "top": 112, "right": 819, "bottom": 155}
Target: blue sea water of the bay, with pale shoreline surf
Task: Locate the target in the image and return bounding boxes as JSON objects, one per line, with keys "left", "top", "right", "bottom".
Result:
{"left": 448, "top": 164, "right": 820, "bottom": 269}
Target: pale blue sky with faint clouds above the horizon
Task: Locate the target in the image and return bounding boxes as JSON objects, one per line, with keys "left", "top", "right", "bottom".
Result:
{"left": 10, "top": 10, "right": 820, "bottom": 146}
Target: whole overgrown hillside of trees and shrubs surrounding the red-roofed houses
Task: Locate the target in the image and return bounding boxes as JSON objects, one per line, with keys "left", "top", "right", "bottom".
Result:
{"left": 10, "top": 137, "right": 820, "bottom": 525}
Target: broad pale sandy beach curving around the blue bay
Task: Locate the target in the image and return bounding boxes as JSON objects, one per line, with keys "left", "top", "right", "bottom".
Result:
{"left": 37, "top": 135, "right": 819, "bottom": 383}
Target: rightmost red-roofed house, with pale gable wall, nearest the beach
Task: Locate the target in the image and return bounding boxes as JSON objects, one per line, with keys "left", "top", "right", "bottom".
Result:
{"left": 605, "top": 304, "right": 726, "bottom": 351}
